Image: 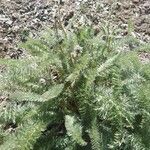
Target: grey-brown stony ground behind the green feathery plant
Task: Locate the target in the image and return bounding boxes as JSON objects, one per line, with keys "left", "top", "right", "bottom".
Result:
{"left": 0, "top": 0, "right": 150, "bottom": 58}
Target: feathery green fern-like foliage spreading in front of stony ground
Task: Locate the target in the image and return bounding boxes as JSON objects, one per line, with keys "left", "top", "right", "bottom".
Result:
{"left": 0, "top": 27, "right": 150, "bottom": 150}
